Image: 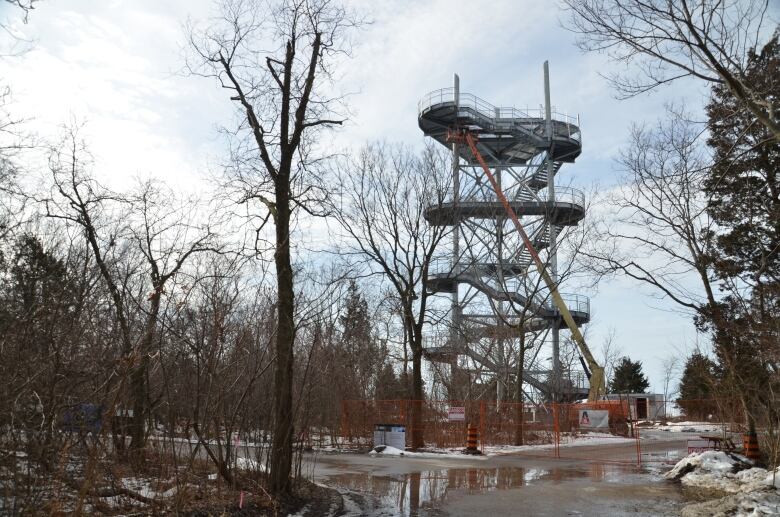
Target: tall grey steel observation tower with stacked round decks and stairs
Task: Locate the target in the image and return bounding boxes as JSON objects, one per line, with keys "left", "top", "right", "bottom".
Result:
{"left": 418, "top": 62, "right": 590, "bottom": 399}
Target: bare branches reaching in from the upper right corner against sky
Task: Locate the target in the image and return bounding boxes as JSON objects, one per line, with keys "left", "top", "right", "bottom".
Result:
{"left": 564, "top": 0, "right": 780, "bottom": 140}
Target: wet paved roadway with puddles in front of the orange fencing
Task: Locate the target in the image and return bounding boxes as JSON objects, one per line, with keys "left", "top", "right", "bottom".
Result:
{"left": 304, "top": 434, "right": 684, "bottom": 516}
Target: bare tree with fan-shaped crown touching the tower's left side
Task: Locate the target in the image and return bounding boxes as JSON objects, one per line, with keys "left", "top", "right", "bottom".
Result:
{"left": 335, "top": 144, "right": 449, "bottom": 448}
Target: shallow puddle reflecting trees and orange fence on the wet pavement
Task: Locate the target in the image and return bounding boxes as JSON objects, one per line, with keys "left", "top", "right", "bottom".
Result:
{"left": 327, "top": 464, "right": 646, "bottom": 516}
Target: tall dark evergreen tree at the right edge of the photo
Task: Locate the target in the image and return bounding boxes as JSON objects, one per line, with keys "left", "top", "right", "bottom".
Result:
{"left": 700, "top": 34, "right": 780, "bottom": 428}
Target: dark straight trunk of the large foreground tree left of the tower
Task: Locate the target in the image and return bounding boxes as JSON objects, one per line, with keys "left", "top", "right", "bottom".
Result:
{"left": 269, "top": 186, "right": 295, "bottom": 496}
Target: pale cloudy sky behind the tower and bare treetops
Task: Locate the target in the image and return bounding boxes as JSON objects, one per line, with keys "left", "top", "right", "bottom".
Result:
{"left": 0, "top": 0, "right": 720, "bottom": 391}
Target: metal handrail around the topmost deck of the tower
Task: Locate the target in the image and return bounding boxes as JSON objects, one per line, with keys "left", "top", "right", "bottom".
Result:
{"left": 417, "top": 87, "right": 580, "bottom": 139}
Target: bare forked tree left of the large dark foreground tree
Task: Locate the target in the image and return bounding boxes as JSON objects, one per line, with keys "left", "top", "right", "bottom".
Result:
{"left": 43, "top": 129, "right": 214, "bottom": 450}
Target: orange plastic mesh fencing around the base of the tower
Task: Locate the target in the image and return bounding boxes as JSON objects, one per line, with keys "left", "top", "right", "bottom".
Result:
{"left": 338, "top": 397, "right": 744, "bottom": 455}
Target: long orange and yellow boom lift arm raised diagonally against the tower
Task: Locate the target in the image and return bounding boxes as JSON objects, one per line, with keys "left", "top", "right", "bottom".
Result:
{"left": 447, "top": 129, "right": 605, "bottom": 402}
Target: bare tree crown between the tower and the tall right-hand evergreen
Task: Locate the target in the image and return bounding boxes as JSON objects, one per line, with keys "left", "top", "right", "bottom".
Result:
{"left": 583, "top": 109, "right": 716, "bottom": 316}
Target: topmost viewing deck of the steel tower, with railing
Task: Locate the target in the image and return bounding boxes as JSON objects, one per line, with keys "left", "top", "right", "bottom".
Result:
{"left": 417, "top": 88, "right": 582, "bottom": 166}
